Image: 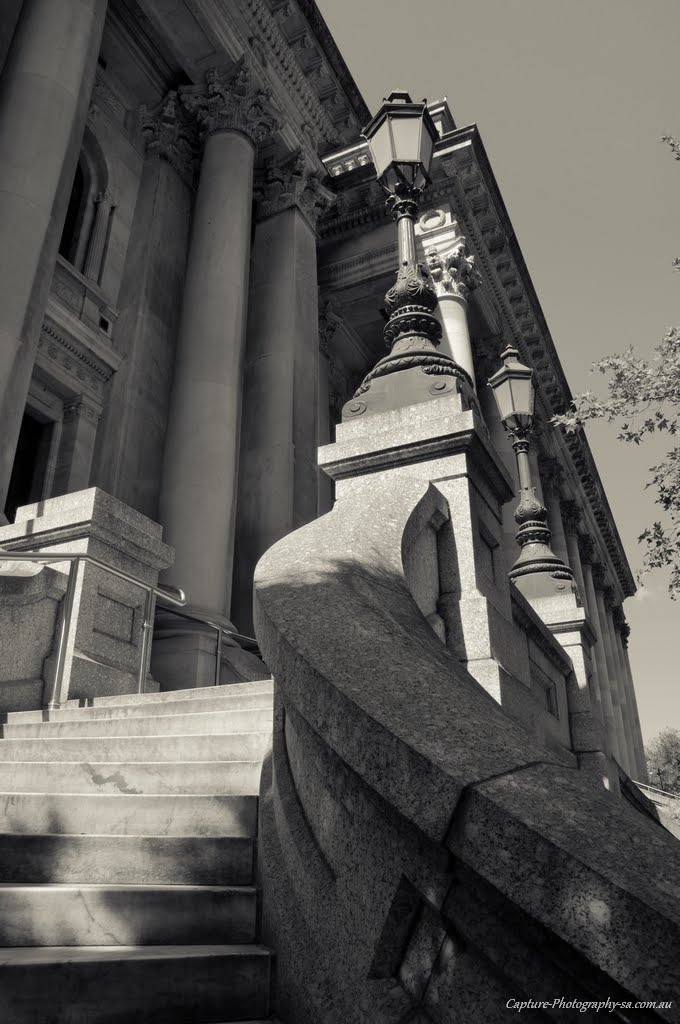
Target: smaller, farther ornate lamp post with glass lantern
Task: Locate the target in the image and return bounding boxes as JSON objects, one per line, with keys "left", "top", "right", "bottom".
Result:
{"left": 488, "top": 346, "right": 573, "bottom": 596}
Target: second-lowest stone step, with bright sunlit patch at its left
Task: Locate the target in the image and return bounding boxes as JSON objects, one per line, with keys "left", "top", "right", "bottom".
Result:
{"left": 0, "top": 884, "right": 257, "bottom": 946}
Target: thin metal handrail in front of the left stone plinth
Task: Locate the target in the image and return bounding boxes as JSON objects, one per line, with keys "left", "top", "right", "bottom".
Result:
{"left": 0, "top": 551, "right": 186, "bottom": 711}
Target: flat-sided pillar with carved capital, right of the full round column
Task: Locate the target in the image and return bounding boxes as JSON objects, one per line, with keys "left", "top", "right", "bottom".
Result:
{"left": 232, "top": 155, "right": 335, "bottom": 632}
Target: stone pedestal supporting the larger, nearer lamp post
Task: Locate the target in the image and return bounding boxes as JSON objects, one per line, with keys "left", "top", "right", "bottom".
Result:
{"left": 320, "top": 395, "right": 589, "bottom": 774}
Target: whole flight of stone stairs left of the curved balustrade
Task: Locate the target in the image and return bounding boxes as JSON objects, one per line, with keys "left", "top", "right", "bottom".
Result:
{"left": 0, "top": 681, "right": 271, "bottom": 1024}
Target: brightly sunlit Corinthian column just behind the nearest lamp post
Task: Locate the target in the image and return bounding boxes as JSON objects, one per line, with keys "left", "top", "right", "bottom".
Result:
{"left": 426, "top": 239, "right": 481, "bottom": 385}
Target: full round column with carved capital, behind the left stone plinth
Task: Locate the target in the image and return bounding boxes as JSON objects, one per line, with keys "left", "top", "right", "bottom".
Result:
{"left": 160, "top": 60, "right": 278, "bottom": 618}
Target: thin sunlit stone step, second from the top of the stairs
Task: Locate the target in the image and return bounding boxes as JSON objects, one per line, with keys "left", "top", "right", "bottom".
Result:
{"left": 2, "top": 703, "right": 271, "bottom": 739}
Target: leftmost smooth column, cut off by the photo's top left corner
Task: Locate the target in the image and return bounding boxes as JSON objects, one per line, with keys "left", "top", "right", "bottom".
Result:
{"left": 0, "top": 0, "right": 107, "bottom": 509}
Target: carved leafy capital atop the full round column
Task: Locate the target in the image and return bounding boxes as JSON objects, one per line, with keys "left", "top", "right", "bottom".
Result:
{"left": 179, "top": 56, "right": 281, "bottom": 145}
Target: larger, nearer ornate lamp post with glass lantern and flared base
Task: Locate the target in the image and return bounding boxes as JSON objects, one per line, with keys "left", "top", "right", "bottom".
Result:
{"left": 343, "top": 91, "right": 472, "bottom": 420}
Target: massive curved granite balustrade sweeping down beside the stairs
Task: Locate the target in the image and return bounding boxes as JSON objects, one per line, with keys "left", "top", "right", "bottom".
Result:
{"left": 255, "top": 468, "right": 680, "bottom": 1024}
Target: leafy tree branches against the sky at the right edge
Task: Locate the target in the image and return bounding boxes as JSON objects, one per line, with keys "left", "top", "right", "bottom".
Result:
{"left": 552, "top": 135, "right": 680, "bottom": 598}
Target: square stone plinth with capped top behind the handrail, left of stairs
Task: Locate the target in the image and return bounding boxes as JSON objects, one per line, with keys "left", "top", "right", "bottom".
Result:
{"left": 0, "top": 487, "right": 172, "bottom": 699}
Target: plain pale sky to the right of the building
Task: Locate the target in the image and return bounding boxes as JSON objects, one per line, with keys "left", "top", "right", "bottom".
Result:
{"left": 317, "top": 0, "right": 680, "bottom": 741}
